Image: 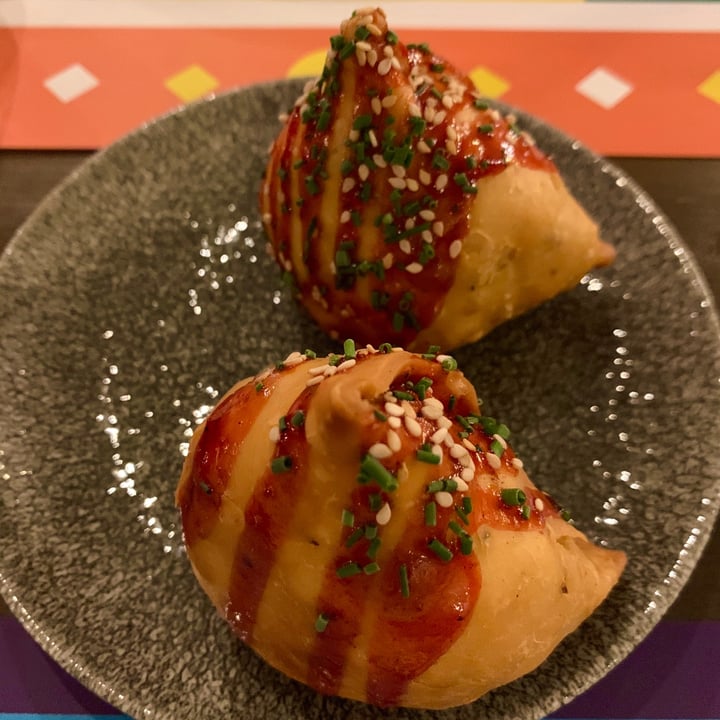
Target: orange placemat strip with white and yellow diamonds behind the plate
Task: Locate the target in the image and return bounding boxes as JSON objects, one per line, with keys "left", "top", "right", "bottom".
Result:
{"left": 0, "top": 0, "right": 720, "bottom": 157}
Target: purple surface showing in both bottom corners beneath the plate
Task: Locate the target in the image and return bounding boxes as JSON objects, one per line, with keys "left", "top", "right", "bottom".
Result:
{"left": 0, "top": 616, "right": 720, "bottom": 720}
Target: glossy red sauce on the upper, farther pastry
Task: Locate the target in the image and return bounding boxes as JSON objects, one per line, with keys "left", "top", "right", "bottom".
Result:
{"left": 268, "top": 19, "right": 556, "bottom": 346}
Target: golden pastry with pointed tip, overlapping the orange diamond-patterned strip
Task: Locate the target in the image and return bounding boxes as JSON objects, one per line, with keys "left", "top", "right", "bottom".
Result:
{"left": 260, "top": 8, "right": 614, "bottom": 350}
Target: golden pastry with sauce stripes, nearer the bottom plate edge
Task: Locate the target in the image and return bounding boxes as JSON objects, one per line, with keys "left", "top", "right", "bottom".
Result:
{"left": 176, "top": 342, "right": 625, "bottom": 708}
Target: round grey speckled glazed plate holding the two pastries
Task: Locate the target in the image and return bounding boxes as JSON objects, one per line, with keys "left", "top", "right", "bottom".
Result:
{"left": 0, "top": 82, "right": 720, "bottom": 720}
